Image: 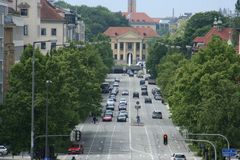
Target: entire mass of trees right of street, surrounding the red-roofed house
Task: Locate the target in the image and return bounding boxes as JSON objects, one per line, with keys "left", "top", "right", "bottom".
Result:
{"left": 146, "top": 3, "right": 240, "bottom": 156}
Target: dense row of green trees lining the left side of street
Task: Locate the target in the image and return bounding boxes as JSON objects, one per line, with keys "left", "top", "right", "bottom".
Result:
{"left": 0, "top": 36, "right": 113, "bottom": 153}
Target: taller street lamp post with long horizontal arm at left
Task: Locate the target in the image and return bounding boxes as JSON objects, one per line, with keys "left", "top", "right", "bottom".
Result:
{"left": 30, "top": 40, "right": 56, "bottom": 160}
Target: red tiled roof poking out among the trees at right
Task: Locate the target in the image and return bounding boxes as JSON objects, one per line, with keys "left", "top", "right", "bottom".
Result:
{"left": 194, "top": 27, "right": 233, "bottom": 44}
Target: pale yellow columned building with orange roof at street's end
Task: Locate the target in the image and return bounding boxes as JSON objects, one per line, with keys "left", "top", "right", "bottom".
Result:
{"left": 104, "top": 27, "right": 158, "bottom": 65}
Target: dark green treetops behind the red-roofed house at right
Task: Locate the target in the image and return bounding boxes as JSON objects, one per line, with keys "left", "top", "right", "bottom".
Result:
{"left": 184, "top": 11, "right": 228, "bottom": 44}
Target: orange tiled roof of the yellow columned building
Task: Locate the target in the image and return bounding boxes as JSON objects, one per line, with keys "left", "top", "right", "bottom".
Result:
{"left": 104, "top": 27, "right": 158, "bottom": 37}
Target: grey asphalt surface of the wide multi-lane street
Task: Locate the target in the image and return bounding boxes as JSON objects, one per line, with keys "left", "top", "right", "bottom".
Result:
{"left": 58, "top": 74, "right": 199, "bottom": 160}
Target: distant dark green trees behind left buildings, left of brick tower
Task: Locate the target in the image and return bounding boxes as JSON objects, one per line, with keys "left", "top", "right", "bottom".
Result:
{"left": 55, "top": 1, "right": 128, "bottom": 41}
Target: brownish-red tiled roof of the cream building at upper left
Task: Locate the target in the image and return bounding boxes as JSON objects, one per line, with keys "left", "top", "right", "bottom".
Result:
{"left": 41, "top": 0, "right": 64, "bottom": 21}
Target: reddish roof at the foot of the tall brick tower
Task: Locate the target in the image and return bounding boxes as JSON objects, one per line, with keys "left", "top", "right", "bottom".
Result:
{"left": 122, "top": 12, "right": 155, "bottom": 23}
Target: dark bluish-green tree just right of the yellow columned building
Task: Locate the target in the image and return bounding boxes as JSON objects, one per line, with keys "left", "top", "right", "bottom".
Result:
{"left": 146, "top": 42, "right": 167, "bottom": 78}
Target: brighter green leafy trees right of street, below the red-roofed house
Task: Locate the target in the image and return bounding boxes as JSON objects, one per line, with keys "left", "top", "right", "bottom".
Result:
{"left": 162, "top": 37, "right": 240, "bottom": 148}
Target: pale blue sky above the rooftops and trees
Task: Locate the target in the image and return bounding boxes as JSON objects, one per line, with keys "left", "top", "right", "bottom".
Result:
{"left": 64, "top": 0, "right": 237, "bottom": 17}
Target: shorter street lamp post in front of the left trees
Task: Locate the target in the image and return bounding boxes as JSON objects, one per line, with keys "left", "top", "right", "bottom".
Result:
{"left": 45, "top": 80, "right": 52, "bottom": 160}
